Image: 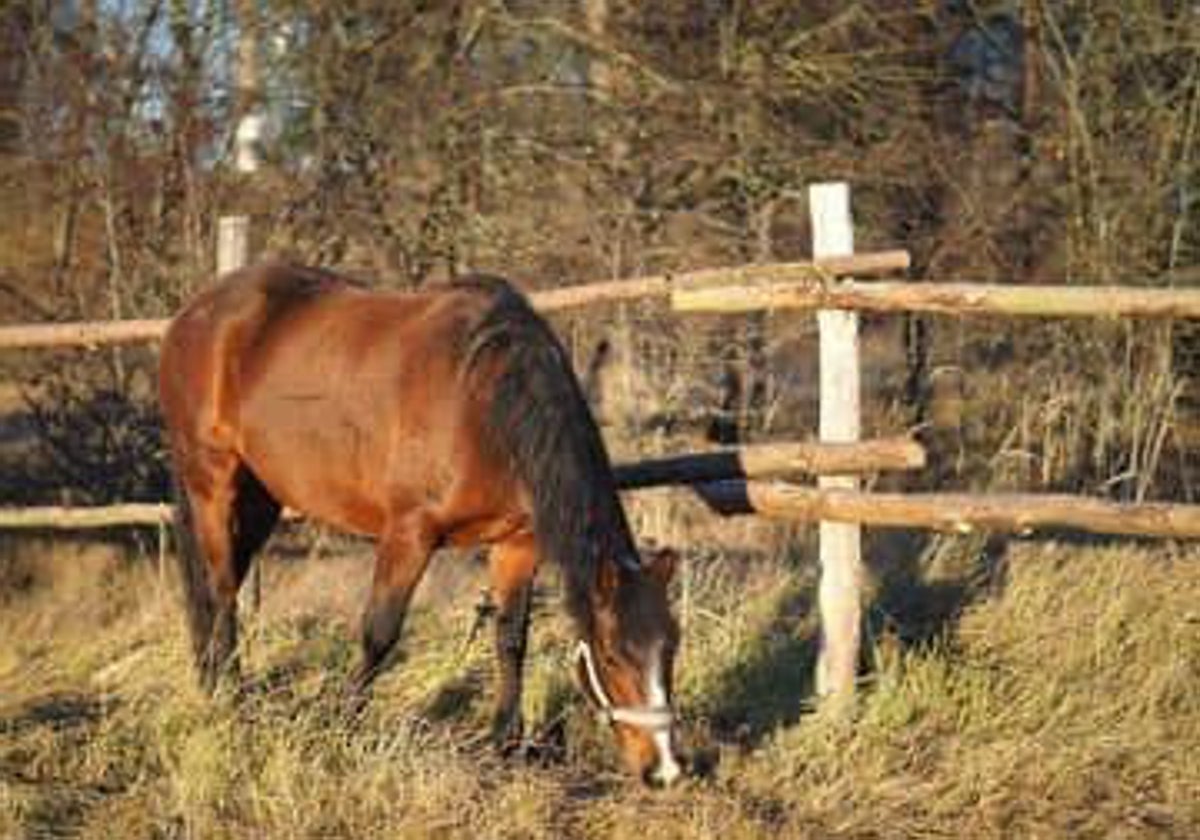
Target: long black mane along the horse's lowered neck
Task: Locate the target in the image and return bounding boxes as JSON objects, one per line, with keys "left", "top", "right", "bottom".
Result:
{"left": 456, "top": 276, "right": 638, "bottom": 634}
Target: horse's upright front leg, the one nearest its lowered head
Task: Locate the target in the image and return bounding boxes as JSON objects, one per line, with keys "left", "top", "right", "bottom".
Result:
{"left": 488, "top": 535, "right": 538, "bottom": 754}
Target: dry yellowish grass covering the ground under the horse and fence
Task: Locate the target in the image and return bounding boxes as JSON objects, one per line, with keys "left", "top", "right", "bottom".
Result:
{"left": 0, "top": 530, "right": 1200, "bottom": 838}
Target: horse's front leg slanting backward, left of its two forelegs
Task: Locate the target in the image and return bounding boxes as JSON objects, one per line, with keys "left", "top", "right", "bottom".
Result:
{"left": 349, "top": 514, "right": 436, "bottom": 708}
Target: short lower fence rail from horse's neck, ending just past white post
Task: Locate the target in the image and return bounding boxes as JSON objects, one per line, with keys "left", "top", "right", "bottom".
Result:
{"left": 614, "top": 437, "right": 925, "bottom": 490}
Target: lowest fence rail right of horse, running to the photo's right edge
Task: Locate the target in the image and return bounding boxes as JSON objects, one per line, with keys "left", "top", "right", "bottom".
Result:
{"left": 696, "top": 481, "right": 1200, "bottom": 539}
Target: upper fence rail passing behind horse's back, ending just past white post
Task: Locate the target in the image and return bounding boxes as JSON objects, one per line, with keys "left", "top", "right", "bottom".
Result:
{"left": 0, "top": 251, "right": 908, "bottom": 349}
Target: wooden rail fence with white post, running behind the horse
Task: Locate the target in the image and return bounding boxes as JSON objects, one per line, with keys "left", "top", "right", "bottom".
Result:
{"left": 0, "top": 185, "right": 1200, "bottom": 700}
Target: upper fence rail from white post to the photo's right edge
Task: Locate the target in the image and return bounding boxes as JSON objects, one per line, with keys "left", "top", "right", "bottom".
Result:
{"left": 671, "top": 281, "right": 1200, "bottom": 318}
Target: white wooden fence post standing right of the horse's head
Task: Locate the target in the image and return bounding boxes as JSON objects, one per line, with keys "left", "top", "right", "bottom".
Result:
{"left": 809, "top": 182, "right": 863, "bottom": 708}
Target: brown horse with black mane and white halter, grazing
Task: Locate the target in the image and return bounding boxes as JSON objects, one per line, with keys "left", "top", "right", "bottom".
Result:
{"left": 160, "top": 264, "right": 680, "bottom": 784}
